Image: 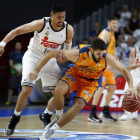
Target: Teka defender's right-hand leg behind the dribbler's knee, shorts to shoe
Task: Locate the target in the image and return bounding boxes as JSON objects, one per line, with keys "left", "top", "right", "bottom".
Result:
{"left": 39, "top": 69, "right": 60, "bottom": 127}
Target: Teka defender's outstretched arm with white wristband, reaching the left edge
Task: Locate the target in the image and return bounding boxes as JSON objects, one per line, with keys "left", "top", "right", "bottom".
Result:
{"left": 0, "top": 19, "right": 44, "bottom": 56}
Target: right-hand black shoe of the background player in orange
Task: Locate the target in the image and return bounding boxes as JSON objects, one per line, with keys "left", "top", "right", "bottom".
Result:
{"left": 99, "top": 110, "right": 117, "bottom": 122}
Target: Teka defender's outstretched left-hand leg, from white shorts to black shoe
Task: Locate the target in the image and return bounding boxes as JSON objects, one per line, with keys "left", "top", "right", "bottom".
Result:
{"left": 5, "top": 52, "right": 35, "bottom": 135}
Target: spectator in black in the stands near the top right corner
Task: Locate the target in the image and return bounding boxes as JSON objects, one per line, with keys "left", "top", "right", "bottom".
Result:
{"left": 127, "top": 9, "right": 139, "bottom": 35}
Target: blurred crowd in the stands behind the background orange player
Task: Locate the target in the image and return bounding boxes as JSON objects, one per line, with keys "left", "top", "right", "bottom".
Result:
{"left": 77, "top": 4, "right": 140, "bottom": 76}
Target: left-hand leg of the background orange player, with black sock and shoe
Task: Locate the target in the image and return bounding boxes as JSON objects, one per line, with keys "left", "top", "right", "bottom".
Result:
{"left": 88, "top": 75, "right": 105, "bottom": 123}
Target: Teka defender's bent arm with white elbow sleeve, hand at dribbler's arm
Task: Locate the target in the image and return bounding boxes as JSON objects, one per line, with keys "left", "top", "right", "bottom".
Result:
{"left": 56, "top": 24, "right": 74, "bottom": 63}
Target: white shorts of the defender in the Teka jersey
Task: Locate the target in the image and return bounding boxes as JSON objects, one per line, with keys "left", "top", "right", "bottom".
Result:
{"left": 21, "top": 50, "right": 60, "bottom": 91}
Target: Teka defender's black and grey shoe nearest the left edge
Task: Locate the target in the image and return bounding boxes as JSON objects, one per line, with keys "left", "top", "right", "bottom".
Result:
{"left": 5, "top": 114, "right": 20, "bottom": 136}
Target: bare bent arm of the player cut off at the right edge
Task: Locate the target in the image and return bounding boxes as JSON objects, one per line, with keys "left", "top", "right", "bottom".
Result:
{"left": 129, "top": 48, "right": 140, "bottom": 70}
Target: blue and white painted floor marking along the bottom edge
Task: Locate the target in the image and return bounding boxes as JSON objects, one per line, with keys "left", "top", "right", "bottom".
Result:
{"left": 0, "top": 129, "right": 139, "bottom": 140}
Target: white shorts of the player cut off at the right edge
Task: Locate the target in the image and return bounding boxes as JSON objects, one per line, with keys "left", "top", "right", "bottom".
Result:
{"left": 124, "top": 75, "right": 140, "bottom": 91}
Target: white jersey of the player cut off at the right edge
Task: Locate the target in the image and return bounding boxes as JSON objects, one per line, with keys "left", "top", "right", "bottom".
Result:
{"left": 130, "top": 47, "right": 140, "bottom": 76}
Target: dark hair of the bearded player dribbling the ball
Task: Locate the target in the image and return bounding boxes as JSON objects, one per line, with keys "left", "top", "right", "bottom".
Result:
{"left": 90, "top": 37, "right": 106, "bottom": 51}
